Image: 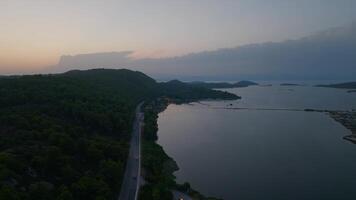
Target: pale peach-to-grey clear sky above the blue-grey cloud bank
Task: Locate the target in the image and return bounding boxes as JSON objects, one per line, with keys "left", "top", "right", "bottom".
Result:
{"left": 0, "top": 0, "right": 356, "bottom": 74}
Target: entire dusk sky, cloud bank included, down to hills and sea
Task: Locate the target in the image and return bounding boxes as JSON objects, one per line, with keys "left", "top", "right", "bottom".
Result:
{"left": 0, "top": 0, "right": 356, "bottom": 80}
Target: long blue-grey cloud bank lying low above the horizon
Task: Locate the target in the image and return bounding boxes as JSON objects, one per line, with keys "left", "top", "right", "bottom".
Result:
{"left": 51, "top": 23, "right": 356, "bottom": 79}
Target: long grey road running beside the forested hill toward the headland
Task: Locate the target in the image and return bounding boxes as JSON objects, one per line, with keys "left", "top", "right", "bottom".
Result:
{"left": 119, "top": 102, "right": 144, "bottom": 200}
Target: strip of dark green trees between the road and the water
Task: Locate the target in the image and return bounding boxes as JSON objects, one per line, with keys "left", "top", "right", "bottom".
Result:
{"left": 140, "top": 98, "right": 178, "bottom": 200}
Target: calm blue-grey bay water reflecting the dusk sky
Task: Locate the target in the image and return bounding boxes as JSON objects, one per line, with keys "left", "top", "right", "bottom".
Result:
{"left": 158, "top": 86, "right": 356, "bottom": 200}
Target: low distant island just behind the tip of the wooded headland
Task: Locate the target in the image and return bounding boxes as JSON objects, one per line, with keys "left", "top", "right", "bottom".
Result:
{"left": 188, "top": 81, "right": 258, "bottom": 89}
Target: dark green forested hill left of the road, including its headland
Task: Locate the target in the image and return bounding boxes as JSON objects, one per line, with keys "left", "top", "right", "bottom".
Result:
{"left": 0, "top": 69, "right": 237, "bottom": 200}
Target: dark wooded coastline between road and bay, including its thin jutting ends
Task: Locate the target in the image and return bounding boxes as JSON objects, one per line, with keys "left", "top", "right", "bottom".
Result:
{"left": 139, "top": 98, "right": 221, "bottom": 200}
